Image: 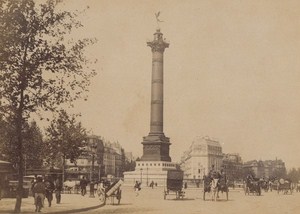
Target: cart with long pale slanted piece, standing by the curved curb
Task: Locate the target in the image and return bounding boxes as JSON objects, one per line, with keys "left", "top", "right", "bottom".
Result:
{"left": 97, "top": 180, "right": 123, "bottom": 205}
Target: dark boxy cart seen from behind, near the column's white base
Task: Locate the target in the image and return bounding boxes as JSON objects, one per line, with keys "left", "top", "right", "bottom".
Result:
{"left": 164, "top": 170, "right": 185, "bottom": 199}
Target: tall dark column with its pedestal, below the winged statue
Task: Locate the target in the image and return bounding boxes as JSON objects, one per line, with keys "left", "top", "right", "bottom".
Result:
{"left": 141, "top": 29, "right": 171, "bottom": 161}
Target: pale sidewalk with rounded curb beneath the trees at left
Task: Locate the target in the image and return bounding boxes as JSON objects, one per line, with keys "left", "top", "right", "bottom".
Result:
{"left": 0, "top": 194, "right": 103, "bottom": 214}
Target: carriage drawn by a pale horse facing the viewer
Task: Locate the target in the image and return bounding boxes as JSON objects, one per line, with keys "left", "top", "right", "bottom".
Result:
{"left": 203, "top": 176, "right": 229, "bottom": 201}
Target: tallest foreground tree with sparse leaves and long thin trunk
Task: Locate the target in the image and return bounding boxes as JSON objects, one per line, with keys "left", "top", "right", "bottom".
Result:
{"left": 0, "top": 0, "right": 95, "bottom": 212}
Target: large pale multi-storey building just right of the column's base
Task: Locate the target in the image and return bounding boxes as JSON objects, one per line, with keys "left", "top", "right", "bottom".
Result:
{"left": 180, "top": 137, "right": 223, "bottom": 179}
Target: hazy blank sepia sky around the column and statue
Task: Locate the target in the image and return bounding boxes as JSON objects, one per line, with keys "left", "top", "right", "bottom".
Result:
{"left": 50, "top": 0, "right": 300, "bottom": 168}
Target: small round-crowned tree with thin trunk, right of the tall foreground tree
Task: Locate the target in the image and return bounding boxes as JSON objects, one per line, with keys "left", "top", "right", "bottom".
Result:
{"left": 46, "top": 110, "right": 87, "bottom": 181}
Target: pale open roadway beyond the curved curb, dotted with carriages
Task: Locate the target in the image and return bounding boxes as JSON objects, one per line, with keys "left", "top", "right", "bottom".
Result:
{"left": 82, "top": 187, "right": 300, "bottom": 214}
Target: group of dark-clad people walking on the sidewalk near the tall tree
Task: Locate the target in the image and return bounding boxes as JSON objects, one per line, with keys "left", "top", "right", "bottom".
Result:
{"left": 31, "top": 176, "right": 63, "bottom": 212}
